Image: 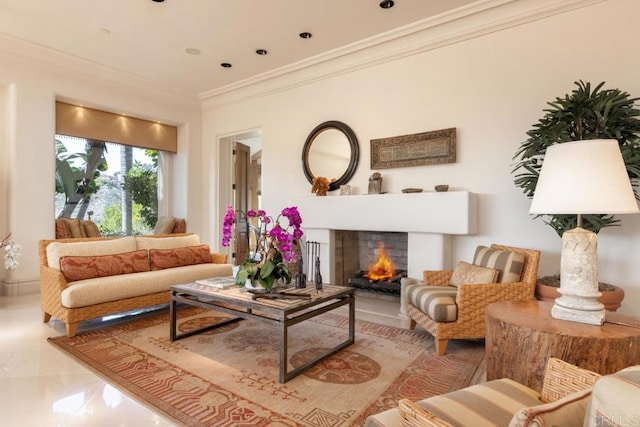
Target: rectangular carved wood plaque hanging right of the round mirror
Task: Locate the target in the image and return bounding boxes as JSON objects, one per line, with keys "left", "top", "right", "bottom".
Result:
{"left": 371, "top": 128, "right": 456, "bottom": 169}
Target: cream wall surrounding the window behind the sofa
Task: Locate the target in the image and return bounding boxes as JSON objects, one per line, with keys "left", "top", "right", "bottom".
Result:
{"left": 0, "top": 38, "right": 202, "bottom": 294}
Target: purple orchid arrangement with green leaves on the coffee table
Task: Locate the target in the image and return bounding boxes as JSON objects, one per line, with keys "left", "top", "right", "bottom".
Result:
{"left": 222, "top": 206, "right": 304, "bottom": 290}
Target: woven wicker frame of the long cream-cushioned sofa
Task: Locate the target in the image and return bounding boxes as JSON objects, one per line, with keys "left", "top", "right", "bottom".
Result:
{"left": 38, "top": 234, "right": 231, "bottom": 337}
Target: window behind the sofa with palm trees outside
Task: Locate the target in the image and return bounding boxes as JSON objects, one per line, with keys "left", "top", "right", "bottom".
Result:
{"left": 55, "top": 135, "right": 159, "bottom": 236}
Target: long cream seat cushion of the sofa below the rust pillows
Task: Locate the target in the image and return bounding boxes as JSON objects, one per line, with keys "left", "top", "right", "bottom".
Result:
{"left": 60, "top": 263, "right": 232, "bottom": 308}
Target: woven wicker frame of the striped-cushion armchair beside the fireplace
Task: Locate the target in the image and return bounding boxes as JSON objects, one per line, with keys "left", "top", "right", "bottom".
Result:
{"left": 407, "top": 244, "right": 540, "bottom": 356}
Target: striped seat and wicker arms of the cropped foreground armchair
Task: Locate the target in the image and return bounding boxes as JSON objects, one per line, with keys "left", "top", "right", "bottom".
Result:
{"left": 398, "top": 358, "right": 600, "bottom": 427}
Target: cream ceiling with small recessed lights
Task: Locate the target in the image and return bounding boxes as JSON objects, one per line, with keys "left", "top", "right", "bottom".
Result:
{"left": 0, "top": 0, "right": 477, "bottom": 96}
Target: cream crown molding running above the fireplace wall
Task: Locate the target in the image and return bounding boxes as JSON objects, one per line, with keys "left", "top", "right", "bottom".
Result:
{"left": 199, "top": 0, "right": 608, "bottom": 111}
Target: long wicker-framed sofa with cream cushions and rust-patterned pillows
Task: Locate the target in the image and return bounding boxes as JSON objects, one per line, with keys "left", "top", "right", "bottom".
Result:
{"left": 39, "top": 234, "right": 232, "bottom": 337}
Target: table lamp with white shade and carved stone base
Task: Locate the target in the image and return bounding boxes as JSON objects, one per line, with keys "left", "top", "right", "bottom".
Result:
{"left": 529, "top": 139, "right": 638, "bottom": 325}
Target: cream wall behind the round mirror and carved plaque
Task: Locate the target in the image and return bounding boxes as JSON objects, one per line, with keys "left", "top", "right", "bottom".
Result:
{"left": 203, "top": 0, "right": 640, "bottom": 315}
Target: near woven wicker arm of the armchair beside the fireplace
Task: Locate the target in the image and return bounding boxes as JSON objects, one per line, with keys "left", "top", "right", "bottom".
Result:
{"left": 456, "top": 282, "right": 535, "bottom": 325}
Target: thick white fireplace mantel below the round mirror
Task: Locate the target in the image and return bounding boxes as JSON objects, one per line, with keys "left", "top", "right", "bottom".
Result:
{"left": 298, "top": 191, "right": 477, "bottom": 235}
